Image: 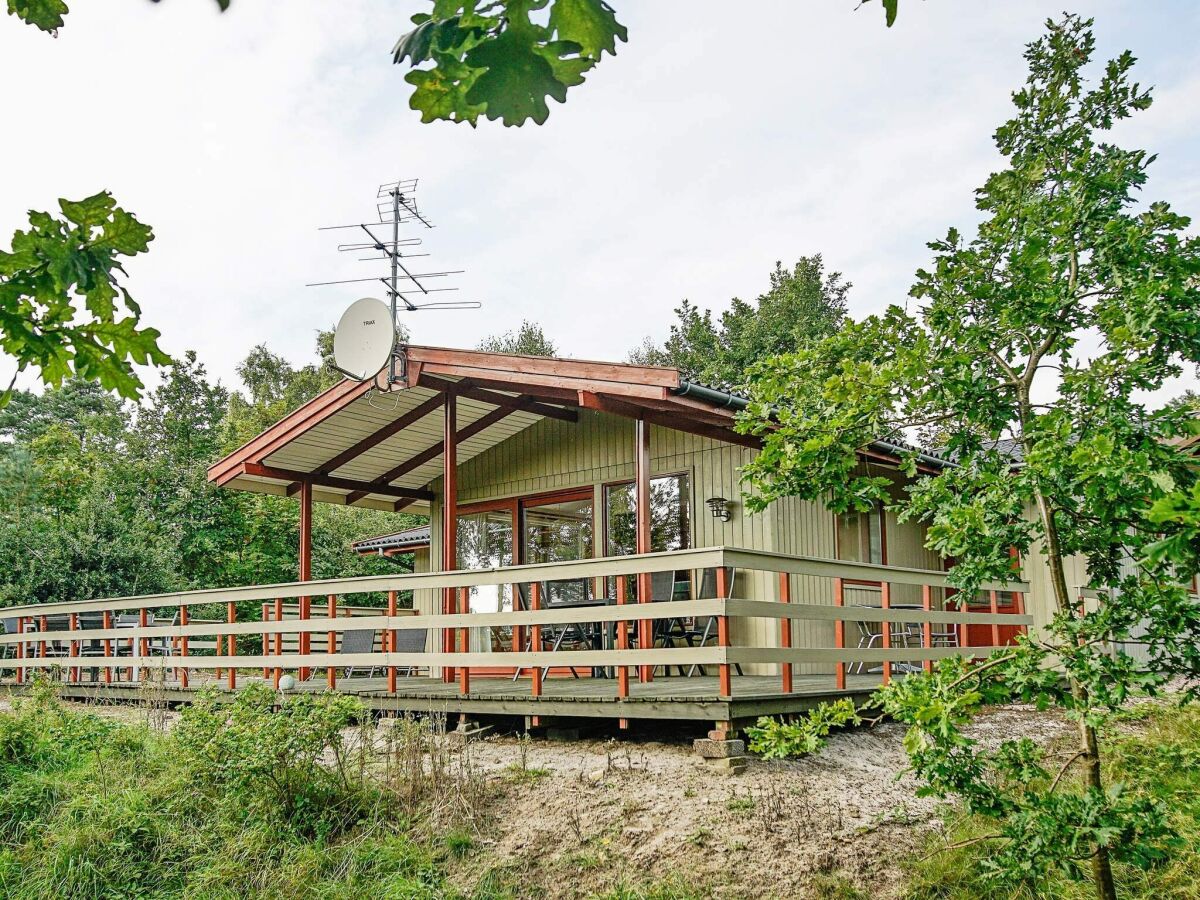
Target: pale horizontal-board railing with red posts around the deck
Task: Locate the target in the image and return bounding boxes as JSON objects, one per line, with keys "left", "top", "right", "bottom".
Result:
{"left": 0, "top": 547, "right": 1032, "bottom": 697}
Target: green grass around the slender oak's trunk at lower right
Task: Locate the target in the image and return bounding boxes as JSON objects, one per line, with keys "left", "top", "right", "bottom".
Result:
{"left": 908, "top": 703, "right": 1200, "bottom": 900}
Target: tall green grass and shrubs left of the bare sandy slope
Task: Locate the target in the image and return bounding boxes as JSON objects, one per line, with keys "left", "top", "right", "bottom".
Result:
{"left": 0, "top": 685, "right": 505, "bottom": 900}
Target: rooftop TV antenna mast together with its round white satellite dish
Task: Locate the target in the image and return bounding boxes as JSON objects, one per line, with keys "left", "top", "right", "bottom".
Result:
{"left": 305, "top": 178, "right": 480, "bottom": 388}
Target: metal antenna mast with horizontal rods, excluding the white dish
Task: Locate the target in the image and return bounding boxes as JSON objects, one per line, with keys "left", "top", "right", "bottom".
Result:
{"left": 305, "top": 178, "right": 480, "bottom": 388}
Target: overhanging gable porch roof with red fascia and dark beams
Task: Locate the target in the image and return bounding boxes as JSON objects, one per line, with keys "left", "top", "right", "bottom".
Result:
{"left": 209, "top": 347, "right": 749, "bottom": 510}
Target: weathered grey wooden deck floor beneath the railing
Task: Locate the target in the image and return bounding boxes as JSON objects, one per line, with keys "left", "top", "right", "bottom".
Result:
{"left": 25, "top": 673, "right": 880, "bottom": 722}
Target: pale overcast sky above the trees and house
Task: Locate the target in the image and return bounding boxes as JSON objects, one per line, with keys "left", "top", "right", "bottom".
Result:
{"left": 0, "top": 0, "right": 1200, "bottom": 400}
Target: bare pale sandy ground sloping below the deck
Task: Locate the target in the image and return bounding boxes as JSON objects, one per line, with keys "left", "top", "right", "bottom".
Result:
{"left": 0, "top": 702, "right": 1072, "bottom": 900}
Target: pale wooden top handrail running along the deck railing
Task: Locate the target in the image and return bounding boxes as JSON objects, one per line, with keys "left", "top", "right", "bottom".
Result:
{"left": 0, "top": 546, "right": 1028, "bottom": 618}
